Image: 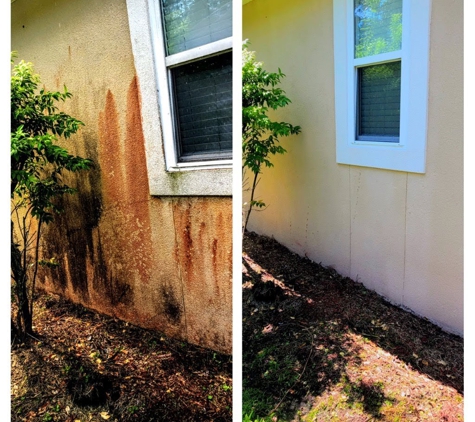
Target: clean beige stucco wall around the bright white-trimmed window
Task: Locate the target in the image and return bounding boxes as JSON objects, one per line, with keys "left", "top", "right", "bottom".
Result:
{"left": 243, "top": 0, "right": 463, "bottom": 334}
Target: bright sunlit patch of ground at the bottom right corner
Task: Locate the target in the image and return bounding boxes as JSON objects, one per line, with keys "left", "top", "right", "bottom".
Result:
{"left": 295, "top": 333, "right": 463, "bottom": 422}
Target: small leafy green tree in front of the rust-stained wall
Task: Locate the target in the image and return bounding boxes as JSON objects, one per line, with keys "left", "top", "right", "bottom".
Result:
{"left": 10, "top": 55, "right": 92, "bottom": 338}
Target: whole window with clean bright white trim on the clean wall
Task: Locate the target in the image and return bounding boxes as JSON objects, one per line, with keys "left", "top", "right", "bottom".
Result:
{"left": 334, "top": 0, "right": 430, "bottom": 173}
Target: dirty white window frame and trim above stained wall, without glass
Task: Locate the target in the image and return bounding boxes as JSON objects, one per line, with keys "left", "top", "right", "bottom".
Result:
{"left": 126, "top": 0, "right": 234, "bottom": 196}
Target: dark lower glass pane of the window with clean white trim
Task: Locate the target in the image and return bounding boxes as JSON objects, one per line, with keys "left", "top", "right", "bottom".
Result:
{"left": 356, "top": 61, "right": 401, "bottom": 142}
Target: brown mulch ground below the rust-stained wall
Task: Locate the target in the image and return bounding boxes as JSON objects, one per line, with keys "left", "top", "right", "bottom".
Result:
{"left": 11, "top": 295, "right": 232, "bottom": 422}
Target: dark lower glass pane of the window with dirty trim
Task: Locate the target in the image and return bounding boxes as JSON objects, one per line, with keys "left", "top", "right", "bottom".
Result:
{"left": 172, "top": 52, "right": 232, "bottom": 161}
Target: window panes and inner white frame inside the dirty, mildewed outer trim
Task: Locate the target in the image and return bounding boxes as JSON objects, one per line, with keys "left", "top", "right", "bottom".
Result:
{"left": 151, "top": 0, "right": 232, "bottom": 171}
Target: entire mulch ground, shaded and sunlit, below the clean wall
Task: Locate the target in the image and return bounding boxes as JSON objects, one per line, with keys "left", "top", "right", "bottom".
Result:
{"left": 243, "top": 232, "right": 463, "bottom": 421}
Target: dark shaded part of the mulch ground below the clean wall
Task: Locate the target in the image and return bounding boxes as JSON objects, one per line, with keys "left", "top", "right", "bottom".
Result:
{"left": 243, "top": 233, "right": 463, "bottom": 420}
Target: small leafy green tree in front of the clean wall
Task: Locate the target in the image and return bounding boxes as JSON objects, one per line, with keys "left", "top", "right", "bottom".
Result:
{"left": 242, "top": 42, "right": 301, "bottom": 230}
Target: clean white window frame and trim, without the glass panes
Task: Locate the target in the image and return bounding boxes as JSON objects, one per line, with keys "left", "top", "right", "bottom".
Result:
{"left": 333, "top": 0, "right": 431, "bottom": 173}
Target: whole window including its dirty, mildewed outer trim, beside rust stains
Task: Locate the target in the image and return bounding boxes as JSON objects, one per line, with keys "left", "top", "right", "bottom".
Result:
{"left": 126, "top": 0, "right": 231, "bottom": 196}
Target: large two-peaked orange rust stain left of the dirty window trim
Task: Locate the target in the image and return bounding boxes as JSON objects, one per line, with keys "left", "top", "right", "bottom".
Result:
{"left": 99, "top": 76, "right": 153, "bottom": 283}
